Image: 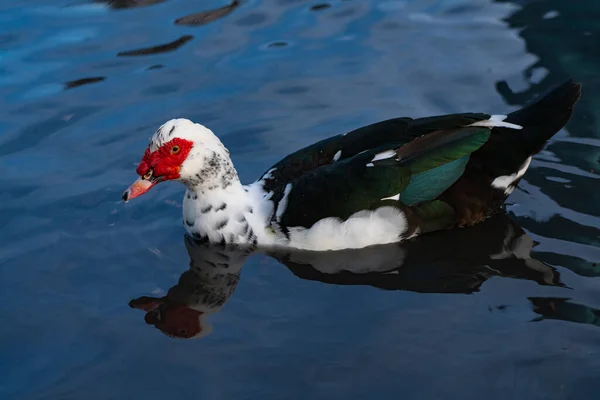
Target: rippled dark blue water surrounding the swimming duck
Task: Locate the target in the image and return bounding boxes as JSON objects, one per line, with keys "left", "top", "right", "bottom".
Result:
{"left": 0, "top": 0, "right": 600, "bottom": 400}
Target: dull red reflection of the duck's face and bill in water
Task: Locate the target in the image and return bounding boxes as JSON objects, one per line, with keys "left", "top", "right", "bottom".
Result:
{"left": 130, "top": 297, "right": 202, "bottom": 339}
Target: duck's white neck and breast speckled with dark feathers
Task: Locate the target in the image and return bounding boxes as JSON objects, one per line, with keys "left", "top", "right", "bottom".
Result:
{"left": 183, "top": 174, "right": 257, "bottom": 246}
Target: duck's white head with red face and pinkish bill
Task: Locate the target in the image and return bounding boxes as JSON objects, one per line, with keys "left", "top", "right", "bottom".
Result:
{"left": 122, "top": 118, "right": 237, "bottom": 202}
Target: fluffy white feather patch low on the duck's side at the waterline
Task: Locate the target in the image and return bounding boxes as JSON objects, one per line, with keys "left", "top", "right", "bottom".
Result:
{"left": 287, "top": 206, "right": 408, "bottom": 251}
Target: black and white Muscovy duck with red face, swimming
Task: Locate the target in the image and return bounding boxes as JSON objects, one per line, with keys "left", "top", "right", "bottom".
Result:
{"left": 122, "top": 79, "right": 581, "bottom": 251}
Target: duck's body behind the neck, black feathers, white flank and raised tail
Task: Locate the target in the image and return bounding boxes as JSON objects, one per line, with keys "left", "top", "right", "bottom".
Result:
{"left": 260, "top": 81, "right": 581, "bottom": 248}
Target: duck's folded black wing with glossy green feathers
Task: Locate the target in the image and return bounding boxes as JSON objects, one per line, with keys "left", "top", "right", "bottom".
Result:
{"left": 272, "top": 123, "right": 491, "bottom": 232}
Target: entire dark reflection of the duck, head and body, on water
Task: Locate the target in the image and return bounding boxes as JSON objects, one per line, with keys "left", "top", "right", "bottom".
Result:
{"left": 130, "top": 214, "right": 563, "bottom": 338}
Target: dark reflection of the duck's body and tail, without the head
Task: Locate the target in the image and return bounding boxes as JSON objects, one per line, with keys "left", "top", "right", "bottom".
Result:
{"left": 270, "top": 214, "right": 564, "bottom": 293}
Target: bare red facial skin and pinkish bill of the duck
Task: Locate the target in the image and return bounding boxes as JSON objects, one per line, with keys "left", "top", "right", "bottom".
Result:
{"left": 123, "top": 138, "right": 193, "bottom": 202}
